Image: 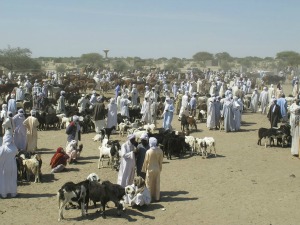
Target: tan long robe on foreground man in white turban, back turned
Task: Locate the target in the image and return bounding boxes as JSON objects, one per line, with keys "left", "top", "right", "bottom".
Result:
{"left": 142, "top": 147, "right": 163, "bottom": 201}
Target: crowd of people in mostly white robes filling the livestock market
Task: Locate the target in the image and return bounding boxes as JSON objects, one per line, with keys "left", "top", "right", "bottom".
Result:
{"left": 0, "top": 70, "right": 300, "bottom": 205}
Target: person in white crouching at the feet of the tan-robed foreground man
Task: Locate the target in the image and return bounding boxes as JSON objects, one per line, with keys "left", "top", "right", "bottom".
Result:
{"left": 125, "top": 177, "right": 151, "bottom": 206}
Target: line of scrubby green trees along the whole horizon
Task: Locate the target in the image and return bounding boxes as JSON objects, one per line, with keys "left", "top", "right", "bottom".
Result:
{"left": 0, "top": 46, "right": 300, "bottom": 72}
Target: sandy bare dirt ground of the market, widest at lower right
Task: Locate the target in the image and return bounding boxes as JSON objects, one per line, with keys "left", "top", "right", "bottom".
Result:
{"left": 0, "top": 82, "right": 300, "bottom": 225}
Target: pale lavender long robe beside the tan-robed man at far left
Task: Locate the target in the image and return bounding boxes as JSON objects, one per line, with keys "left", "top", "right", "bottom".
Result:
{"left": 13, "top": 113, "right": 26, "bottom": 150}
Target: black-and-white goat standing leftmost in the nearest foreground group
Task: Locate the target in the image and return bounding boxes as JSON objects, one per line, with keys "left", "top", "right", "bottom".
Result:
{"left": 57, "top": 180, "right": 90, "bottom": 221}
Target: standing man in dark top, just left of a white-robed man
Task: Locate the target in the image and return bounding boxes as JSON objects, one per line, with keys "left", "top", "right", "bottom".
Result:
{"left": 92, "top": 96, "right": 107, "bottom": 134}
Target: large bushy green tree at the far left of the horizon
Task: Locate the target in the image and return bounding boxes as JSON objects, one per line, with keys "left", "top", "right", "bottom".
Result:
{"left": 0, "top": 46, "right": 41, "bottom": 70}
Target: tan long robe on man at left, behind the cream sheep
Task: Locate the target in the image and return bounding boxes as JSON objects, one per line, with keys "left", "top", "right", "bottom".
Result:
{"left": 23, "top": 116, "right": 40, "bottom": 152}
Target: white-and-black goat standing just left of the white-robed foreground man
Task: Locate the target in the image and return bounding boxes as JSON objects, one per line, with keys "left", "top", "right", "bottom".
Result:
{"left": 98, "top": 139, "right": 121, "bottom": 169}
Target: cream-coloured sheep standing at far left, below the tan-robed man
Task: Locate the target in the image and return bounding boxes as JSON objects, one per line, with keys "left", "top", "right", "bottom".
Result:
{"left": 21, "top": 154, "right": 42, "bottom": 183}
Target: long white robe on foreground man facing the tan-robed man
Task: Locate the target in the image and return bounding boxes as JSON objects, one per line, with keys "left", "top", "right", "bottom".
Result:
{"left": 117, "top": 141, "right": 135, "bottom": 187}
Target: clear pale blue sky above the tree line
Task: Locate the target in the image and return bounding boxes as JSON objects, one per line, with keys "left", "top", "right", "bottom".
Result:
{"left": 0, "top": 0, "right": 300, "bottom": 59}
